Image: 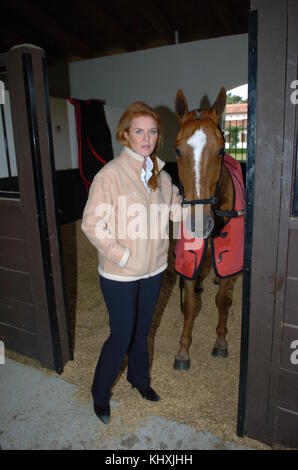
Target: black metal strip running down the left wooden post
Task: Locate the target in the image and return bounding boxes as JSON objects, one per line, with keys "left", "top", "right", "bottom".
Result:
{"left": 23, "top": 53, "right": 63, "bottom": 373}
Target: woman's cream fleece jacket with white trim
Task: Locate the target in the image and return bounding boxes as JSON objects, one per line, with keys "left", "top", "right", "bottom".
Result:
{"left": 81, "top": 147, "right": 181, "bottom": 281}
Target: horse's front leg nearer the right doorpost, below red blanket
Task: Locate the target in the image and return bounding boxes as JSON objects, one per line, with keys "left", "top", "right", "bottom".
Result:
{"left": 212, "top": 276, "right": 237, "bottom": 357}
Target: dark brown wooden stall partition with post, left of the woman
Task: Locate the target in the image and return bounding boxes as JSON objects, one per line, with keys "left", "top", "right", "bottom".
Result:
{"left": 0, "top": 46, "right": 72, "bottom": 372}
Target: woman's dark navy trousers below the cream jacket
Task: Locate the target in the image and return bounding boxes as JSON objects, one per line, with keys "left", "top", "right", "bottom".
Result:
{"left": 92, "top": 273, "right": 162, "bottom": 406}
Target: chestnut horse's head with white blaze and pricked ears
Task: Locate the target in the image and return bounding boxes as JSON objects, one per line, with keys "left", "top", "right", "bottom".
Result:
{"left": 175, "top": 87, "right": 226, "bottom": 238}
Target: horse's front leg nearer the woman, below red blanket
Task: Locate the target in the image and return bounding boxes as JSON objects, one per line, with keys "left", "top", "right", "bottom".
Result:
{"left": 174, "top": 279, "right": 202, "bottom": 370}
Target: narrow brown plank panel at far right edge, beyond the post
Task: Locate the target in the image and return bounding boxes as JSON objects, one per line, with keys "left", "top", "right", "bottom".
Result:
{"left": 269, "top": 0, "right": 298, "bottom": 447}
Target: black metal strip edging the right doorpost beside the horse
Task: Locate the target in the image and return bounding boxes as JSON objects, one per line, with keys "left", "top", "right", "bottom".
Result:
{"left": 237, "top": 11, "right": 258, "bottom": 437}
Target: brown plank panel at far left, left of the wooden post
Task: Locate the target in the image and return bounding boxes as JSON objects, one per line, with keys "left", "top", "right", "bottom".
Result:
{"left": 0, "top": 199, "right": 38, "bottom": 358}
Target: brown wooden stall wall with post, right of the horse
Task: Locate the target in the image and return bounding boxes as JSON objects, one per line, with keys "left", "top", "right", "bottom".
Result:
{"left": 245, "top": 0, "right": 298, "bottom": 447}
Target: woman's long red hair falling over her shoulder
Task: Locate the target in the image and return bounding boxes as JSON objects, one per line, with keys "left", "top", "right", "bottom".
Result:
{"left": 116, "top": 101, "right": 162, "bottom": 191}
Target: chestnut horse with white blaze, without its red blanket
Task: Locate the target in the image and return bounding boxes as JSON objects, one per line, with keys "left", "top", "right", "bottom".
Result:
{"left": 174, "top": 87, "right": 244, "bottom": 370}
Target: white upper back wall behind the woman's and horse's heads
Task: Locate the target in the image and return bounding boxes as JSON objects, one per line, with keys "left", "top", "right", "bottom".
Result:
{"left": 69, "top": 34, "right": 248, "bottom": 162}
